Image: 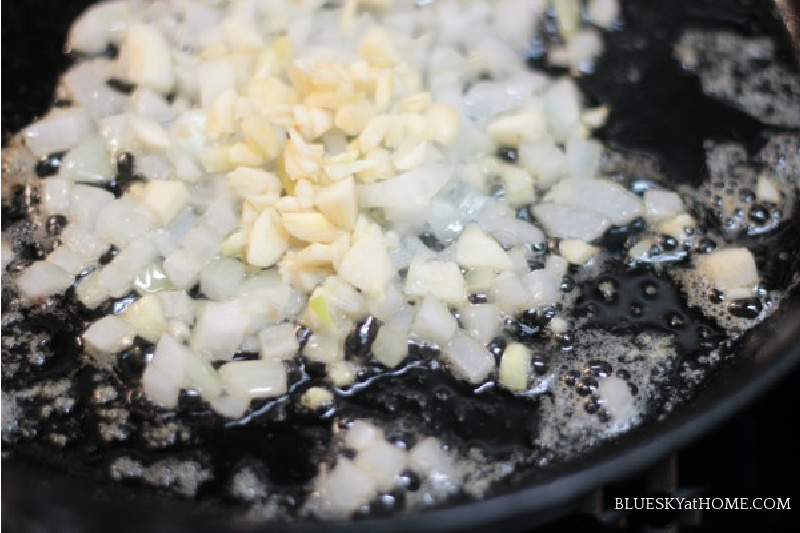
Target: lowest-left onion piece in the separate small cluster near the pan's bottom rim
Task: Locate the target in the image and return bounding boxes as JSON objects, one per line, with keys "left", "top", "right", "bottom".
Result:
{"left": 316, "top": 457, "right": 377, "bottom": 517}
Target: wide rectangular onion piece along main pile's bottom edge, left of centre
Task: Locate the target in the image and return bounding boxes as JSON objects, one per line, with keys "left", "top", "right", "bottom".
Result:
{"left": 219, "top": 359, "right": 286, "bottom": 398}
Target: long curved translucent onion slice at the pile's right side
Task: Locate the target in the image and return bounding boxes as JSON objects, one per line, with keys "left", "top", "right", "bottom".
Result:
{"left": 544, "top": 179, "right": 644, "bottom": 224}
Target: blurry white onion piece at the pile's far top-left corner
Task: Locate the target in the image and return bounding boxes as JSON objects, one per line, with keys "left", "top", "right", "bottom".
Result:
{"left": 67, "top": 1, "right": 129, "bottom": 53}
